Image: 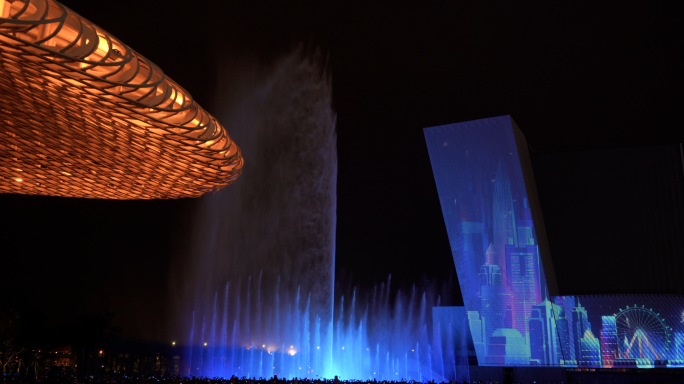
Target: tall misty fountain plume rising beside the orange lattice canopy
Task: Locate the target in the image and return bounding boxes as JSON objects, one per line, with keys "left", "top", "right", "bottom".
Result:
{"left": 171, "top": 49, "right": 337, "bottom": 377}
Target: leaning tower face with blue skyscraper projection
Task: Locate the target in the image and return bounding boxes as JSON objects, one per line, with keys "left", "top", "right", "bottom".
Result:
{"left": 425, "top": 116, "right": 560, "bottom": 365}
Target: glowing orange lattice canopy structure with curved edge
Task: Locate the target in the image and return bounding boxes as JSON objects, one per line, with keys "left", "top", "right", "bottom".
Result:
{"left": 0, "top": 0, "right": 243, "bottom": 199}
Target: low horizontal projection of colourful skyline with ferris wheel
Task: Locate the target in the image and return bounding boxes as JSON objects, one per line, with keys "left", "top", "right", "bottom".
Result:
{"left": 553, "top": 295, "right": 684, "bottom": 368}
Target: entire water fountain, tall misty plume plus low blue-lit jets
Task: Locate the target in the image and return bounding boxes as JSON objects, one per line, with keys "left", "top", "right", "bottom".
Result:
{"left": 171, "top": 49, "right": 464, "bottom": 381}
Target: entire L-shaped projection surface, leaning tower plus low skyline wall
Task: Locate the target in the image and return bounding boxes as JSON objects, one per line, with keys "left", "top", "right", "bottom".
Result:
{"left": 424, "top": 116, "right": 684, "bottom": 368}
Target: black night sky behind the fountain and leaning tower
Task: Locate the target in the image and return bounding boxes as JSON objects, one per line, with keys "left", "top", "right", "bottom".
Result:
{"left": 0, "top": 0, "right": 684, "bottom": 339}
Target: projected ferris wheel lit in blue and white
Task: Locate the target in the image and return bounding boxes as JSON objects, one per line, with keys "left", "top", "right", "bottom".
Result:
{"left": 615, "top": 305, "right": 672, "bottom": 360}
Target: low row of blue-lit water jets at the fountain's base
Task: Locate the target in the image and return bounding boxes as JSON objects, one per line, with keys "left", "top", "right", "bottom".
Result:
{"left": 183, "top": 278, "right": 465, "bottom": 382}
